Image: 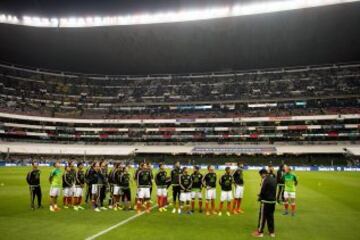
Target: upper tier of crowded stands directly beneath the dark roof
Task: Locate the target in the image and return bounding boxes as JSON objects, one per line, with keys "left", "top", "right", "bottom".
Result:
{"left": 0, "top": 63, "right": 360, "bottom": 119}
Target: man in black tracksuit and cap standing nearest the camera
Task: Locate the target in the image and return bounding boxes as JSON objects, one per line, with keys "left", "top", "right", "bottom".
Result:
{"left": 254, "top": 169, "right": 276, "bottom": 237}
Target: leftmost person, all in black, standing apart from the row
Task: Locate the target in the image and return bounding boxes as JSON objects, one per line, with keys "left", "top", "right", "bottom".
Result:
{"left": 26, "top": 162, "right": 42, "bottom": 210}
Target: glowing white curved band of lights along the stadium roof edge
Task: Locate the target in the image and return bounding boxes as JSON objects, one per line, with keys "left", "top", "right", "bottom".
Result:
{"left": 0, "top": 0, "right": 360, "bottom": 28}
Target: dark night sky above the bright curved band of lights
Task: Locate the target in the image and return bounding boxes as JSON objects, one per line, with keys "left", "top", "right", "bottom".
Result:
{"left": 0, "top": 0, "right": 268, "bottom": 16}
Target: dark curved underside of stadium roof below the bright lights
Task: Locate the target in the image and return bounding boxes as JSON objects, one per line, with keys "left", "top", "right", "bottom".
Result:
{"left": 0, "top": 0, "right": 360, "bottom": 74}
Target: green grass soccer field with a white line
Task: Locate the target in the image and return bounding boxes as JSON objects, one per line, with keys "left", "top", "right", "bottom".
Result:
{"left": 0, "top": 167, "right": 360, "bottom": 240}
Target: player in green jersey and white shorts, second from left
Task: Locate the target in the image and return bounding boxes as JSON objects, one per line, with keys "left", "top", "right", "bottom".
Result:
{"left": 49, "top": 161, "right": 62, "bottom": 212}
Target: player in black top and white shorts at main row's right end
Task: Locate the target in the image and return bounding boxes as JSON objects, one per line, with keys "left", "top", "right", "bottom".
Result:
{"left": 233, "top": 163, "right": 244, "bottom": 214}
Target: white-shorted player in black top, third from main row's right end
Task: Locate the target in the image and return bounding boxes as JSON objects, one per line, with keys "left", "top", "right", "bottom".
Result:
{"left": 202, "top": 165, "right": 217, "bottom": 216}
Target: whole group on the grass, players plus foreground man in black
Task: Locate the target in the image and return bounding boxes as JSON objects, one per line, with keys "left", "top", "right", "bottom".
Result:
{"left": 26, "top": 161, "right": 298, "bottom": 237}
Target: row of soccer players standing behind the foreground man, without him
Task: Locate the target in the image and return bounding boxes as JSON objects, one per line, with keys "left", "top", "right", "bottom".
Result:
{"left": 27, "top": 161, "right": 297, "bottom": 215}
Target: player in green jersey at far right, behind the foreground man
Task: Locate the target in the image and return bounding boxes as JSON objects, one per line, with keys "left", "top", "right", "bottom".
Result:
{"left": 283, "top": 166, "right": 298, "bottom": 216}
